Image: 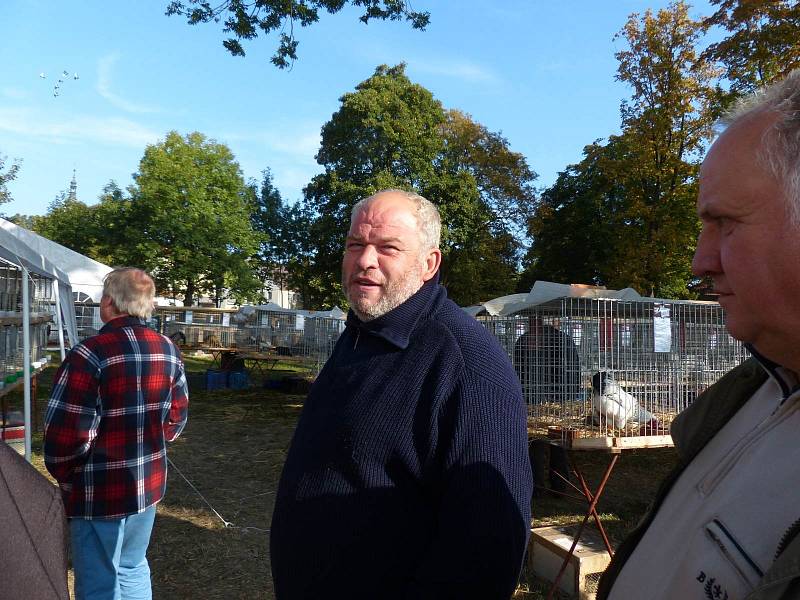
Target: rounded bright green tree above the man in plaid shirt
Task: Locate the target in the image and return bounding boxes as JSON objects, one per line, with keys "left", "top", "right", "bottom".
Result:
{"left": 126, "top": 131, "right": 260, "bottom": 305}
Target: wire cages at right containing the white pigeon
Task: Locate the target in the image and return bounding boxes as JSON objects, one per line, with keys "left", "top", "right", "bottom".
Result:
{"left": 478, "top": 297, "right": 746, "bottom": 446}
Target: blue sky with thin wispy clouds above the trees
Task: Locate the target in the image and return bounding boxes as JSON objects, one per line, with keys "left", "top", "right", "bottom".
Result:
{"left": 0, "top": 0, "right": 709, "bottom": 214}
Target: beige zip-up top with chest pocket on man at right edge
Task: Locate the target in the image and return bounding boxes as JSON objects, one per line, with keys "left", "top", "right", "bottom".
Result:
{"left": 609, "top": 357, "right": 800, "bottom": 600}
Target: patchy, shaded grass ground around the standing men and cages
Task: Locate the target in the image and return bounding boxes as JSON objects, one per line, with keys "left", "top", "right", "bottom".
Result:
{"left": 9, "top": 356, "right": 675, "bottom": 600}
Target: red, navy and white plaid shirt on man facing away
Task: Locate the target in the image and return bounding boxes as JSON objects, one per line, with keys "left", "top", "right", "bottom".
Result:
{"left": 44, "top": 316, "right": 189, "bottom": 519}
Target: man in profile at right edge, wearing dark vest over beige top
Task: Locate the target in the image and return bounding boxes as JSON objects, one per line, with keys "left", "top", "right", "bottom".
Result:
{"left": 598, "top": 70, "right": 800, "bottom": 600}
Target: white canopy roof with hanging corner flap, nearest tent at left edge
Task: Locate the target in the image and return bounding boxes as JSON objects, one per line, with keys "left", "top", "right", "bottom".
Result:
{"left": 0, "top": 219, "right": 78, "bottom": 345}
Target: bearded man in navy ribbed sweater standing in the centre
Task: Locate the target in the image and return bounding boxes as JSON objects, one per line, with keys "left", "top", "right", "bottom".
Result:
{"left": 271, "top": 190, "right": 532, "bottom": 600}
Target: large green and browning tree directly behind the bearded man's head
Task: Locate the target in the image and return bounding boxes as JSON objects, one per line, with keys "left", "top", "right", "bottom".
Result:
{"left": 304, "top": 64, "right": 535, "bottom": 306}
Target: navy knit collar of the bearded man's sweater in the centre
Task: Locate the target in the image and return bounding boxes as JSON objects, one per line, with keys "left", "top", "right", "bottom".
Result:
{"left": 347, "top": 272, "right": 447, "bottom": 350}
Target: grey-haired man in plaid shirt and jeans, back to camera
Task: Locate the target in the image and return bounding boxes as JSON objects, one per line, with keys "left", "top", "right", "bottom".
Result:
{"left": 44, "top": 268, "right": 189, "bottom": 600}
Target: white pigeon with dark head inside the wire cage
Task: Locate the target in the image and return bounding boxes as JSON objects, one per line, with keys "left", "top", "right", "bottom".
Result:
{"left": 592, "top": 371, "right": 663, "bottom": 432}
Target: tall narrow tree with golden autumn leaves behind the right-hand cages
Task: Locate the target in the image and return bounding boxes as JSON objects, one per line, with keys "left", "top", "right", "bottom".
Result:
{"left": 613, "top": 2, "right": 718, "bottom": 296}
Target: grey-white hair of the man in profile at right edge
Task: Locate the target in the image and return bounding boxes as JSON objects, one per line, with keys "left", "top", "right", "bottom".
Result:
{"left": 720, "top": 69, "right": 800, "bottom": 226}
